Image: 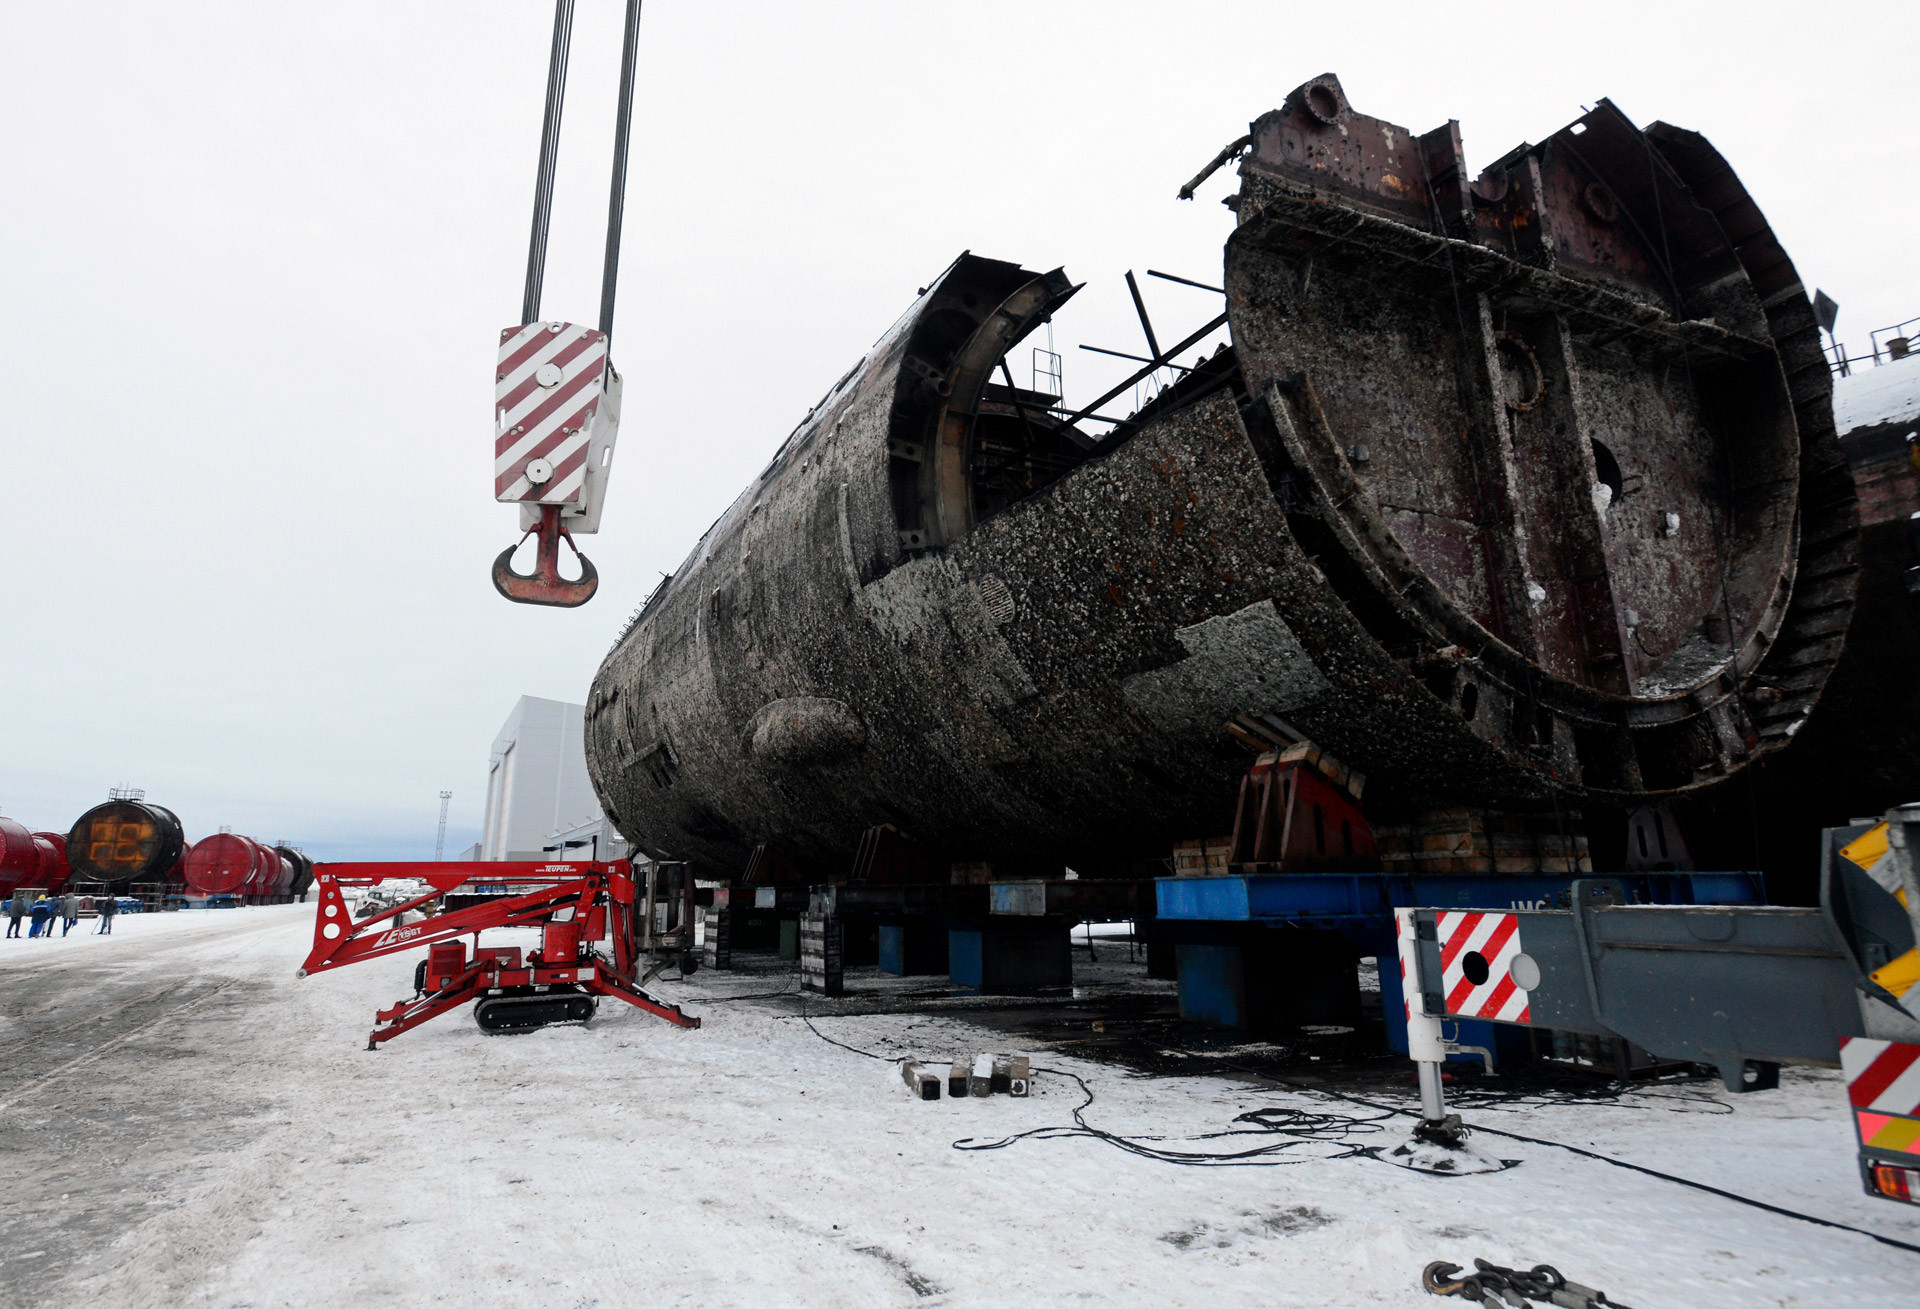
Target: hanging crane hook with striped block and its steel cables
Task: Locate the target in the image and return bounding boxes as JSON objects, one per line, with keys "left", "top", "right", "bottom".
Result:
{"left": 493, "top": 0, "right": 639, "bottom": 608}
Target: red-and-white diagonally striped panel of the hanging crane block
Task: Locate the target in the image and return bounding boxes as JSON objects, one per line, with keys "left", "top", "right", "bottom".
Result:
{"left": 493, "top": 322, "right": 607, "bottom": 505}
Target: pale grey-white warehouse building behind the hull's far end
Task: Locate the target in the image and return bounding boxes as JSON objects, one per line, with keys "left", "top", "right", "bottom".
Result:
{"left": 470, "top": 695, "right": 610, "bottom": 860}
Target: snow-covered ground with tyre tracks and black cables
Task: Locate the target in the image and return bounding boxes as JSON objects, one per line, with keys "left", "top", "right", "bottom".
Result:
{"left": 0, "top": 906, "right": 1920, "bottom": 1309}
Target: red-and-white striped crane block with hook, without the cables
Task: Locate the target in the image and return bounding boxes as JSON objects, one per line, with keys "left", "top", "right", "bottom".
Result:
{"left": 493, "top": 322, "right": 620, "bottom": 607}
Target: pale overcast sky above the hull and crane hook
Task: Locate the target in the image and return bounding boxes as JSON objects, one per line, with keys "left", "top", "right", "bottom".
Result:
{"left": 0, "top": 0, "right": 1920, "bottom": 858}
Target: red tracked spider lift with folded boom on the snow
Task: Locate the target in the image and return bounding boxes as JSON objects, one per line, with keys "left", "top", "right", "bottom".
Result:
{"left": 300, "top": 860, "right": 701, "bottom": 1050}
